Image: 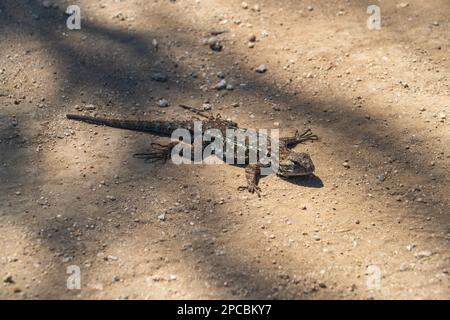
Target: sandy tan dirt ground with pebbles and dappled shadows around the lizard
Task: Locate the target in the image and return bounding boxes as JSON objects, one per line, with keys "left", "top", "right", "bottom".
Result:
{"left": 0, "top": 0, "right": 450, "bottom": 299}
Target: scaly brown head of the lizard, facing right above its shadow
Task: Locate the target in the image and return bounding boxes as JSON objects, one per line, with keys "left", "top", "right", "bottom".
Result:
{"left": 277, "top": 152, "right": 315, "bottom": 177}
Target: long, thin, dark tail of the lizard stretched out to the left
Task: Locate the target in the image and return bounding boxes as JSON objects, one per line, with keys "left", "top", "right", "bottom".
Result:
{"left": 66, "top": 114, "right": 172, "bottom": 136}
